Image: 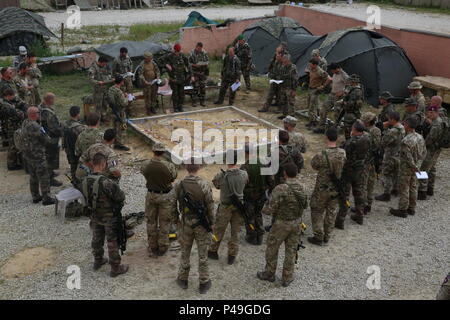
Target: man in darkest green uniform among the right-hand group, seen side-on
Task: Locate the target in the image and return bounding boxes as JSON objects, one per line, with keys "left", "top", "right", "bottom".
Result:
{"left": 335, "top": 120, "right": 370, "bottom": 229}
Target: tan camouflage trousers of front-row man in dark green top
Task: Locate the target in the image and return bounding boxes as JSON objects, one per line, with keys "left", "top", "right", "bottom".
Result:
{"left": 145, "top": 192, "right": 175, "bottom": 252}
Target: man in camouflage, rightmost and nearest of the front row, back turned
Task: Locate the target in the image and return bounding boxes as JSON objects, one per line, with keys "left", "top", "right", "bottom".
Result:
{"left": 256, "top": 164, "right": 308, "bottom": 287}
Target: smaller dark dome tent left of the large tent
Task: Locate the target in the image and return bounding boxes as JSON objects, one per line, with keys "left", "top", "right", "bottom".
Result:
{"left": 243, "top": 17, "right": 311, "bottom": 74}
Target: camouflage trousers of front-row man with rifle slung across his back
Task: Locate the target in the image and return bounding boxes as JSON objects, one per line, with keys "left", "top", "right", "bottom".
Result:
{"left": 178, "top": 219, "right": 210, "bottom": 283}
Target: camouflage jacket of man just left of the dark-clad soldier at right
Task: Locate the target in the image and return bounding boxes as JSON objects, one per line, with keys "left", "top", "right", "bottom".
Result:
{"left": 311, "top": 148, "right": 347, "bottom": 192}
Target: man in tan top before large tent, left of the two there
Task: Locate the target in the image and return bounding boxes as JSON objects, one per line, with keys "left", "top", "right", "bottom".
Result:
{"left": 306, "top": 58, "right": 329, "bottom": 130}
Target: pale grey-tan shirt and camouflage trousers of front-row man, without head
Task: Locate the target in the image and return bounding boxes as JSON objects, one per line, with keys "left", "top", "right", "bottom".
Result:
{"left": 210, "top": 168, "right": 248, "bottom": 257}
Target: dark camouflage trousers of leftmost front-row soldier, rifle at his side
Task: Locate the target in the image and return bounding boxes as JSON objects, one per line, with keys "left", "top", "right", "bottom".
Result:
{"left": 89, "top": 220, "right": 121, "bottom": 265}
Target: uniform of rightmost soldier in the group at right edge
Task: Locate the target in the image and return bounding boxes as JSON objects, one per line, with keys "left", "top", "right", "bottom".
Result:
{"left": 419, "top": 117, "right": 443, "bottom": 192}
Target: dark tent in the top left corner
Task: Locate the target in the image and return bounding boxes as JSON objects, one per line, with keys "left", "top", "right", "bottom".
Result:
{"left": 0, "top": 7, "right": 56, "bottom": 56}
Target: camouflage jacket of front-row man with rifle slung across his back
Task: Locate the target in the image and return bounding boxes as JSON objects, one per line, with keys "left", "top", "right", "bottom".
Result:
{"left": 174, "top": 175, "right": 214, "bottom": 226}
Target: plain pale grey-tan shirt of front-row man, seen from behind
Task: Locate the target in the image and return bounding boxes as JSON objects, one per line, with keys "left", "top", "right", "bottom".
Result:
{"left": 213, "top": 168, "right": 248, "bottom": 206}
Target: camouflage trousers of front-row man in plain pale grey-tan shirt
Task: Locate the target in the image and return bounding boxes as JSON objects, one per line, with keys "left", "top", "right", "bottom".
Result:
{"left": 210, "top": 204, "right": 244, "bottom": 257}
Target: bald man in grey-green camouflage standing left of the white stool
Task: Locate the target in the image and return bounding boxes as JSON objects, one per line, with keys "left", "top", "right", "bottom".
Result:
{"left": 22, "top": 107, "right": 55, "bottom": 206}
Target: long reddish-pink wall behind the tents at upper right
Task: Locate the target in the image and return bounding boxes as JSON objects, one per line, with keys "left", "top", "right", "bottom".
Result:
{"left": 276, "top": 5, "right": 450, "bottom": 78}
